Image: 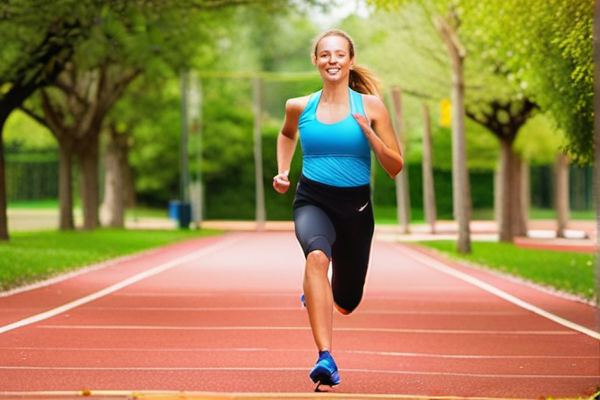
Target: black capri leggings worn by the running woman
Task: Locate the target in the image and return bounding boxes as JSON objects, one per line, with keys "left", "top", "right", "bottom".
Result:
{"left": 292, "top": 176, "right": 374, "bottom": 312}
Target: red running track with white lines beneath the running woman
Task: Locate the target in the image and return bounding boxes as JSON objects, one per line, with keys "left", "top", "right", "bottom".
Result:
{"left": 0, "top": 232, "right": 600, "bottom": 399}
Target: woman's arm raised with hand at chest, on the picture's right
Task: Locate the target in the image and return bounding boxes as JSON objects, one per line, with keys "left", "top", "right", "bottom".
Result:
{"left": 354, "top": 96, "right": 404, "bottom": 178}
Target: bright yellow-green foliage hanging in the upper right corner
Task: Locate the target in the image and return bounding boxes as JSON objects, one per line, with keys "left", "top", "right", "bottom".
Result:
{"left": 369, "top": 0, "right": 593, "bottom": 163}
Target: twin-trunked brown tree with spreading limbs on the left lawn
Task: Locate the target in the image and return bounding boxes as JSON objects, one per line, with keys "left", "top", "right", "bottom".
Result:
{"left": 25, "top": 59, "right": 141, "bottom": 229}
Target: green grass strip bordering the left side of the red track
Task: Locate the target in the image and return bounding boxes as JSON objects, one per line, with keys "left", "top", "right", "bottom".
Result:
{"left": 0, "top": 229, "right": 218, "bottom": 291}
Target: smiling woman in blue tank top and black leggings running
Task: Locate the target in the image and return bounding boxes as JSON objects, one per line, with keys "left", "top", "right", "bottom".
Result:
{"left": 273, "top": 29, "right": 403, "bottom": 390}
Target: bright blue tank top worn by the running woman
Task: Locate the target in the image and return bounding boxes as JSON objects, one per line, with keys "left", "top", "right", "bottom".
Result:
{"left": 298, "top": 88, "right": 371, "bottom": 187}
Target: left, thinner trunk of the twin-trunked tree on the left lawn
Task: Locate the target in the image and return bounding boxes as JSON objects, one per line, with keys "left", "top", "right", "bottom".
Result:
{"left": 58, "top": 141, "right": 75, "bottom": 231}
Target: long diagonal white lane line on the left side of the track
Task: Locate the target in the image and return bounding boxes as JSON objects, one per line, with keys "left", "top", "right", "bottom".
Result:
{"left": 0, "top": 236, "right": 240, "bottom": 334}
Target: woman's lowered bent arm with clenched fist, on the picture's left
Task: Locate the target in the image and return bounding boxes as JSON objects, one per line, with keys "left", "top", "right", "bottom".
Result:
{"left": 273, "top": 98, "right": 306, "bottom": 193}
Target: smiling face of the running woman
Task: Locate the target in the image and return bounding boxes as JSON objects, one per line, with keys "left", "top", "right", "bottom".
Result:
{"left": 312, "top": 35, "right": 354, "bottom": 83}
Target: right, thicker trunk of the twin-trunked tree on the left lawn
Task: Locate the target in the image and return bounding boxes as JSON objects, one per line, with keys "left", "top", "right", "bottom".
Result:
{"left": 77, "top": 135, "right": 100, "bottom": 230}
